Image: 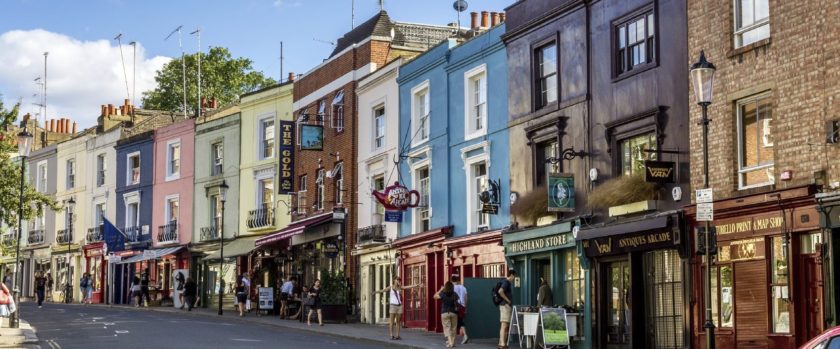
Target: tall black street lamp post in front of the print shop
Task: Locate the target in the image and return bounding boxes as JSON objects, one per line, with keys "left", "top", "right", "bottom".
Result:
{"left": 691, "top": 51, "right": 715, "bottom": 349}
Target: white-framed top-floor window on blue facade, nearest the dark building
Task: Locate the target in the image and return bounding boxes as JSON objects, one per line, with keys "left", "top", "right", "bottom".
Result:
{"left": 464, "top": 63, "right": 488, "bottom": 140}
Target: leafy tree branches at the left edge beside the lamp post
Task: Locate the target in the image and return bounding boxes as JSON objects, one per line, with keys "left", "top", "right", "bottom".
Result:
{"left": 0, "top": 98, "right": 61, "bottom": 239}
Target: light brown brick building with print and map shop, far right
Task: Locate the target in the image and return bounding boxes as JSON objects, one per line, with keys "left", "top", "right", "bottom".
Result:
{"left": 686, "top": 0, "right": 840, "bottom": 348}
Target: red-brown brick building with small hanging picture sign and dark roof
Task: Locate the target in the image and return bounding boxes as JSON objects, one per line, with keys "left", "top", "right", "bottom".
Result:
{"left": 257, "top": 11, "right": 454, "bottom": 318}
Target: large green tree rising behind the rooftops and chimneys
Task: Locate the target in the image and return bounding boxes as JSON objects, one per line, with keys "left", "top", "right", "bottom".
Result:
{"left": 143, "top": 47, "right": 275, "bottom": 114}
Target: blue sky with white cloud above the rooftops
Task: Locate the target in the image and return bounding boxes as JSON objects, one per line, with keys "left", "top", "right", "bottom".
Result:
{"left": 0, "top": 0, "right": 513, "bottom": 126}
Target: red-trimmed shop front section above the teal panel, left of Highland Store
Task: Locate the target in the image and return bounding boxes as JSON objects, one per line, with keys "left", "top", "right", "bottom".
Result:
{"left": 443, "top": 230, "right": 506, "bottom": 280}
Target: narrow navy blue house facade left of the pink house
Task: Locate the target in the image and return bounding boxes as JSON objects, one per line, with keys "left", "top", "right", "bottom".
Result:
{"left": 115, "top": 131, "right": 154, "bottom": 250}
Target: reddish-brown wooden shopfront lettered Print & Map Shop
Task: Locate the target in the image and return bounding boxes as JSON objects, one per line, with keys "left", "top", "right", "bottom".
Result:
{"left": 686, "top": 186, "right": 827, "bottom": 349}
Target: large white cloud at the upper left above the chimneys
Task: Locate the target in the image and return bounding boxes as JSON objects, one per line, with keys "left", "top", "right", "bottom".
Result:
{"left": 0, "top": 29, "right": 171, "bottom": 129}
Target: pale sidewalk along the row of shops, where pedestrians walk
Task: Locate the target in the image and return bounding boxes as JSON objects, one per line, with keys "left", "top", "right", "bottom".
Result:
{"left": 106, "top": 305, "right": 498, "bottom": 349}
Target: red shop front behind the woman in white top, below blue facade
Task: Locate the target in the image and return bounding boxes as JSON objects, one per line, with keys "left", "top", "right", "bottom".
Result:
{"left": 393, "top": 227, "right": 452, "bottom": 332}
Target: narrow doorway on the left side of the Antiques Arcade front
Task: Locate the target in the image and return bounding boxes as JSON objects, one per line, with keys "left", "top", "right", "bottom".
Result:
{"left": 605, "top": 260, "right": 633, "bottom": 349}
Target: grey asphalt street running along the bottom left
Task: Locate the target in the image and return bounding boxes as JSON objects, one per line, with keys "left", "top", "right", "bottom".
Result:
{"left": 21, "top": 302, "right": 393, "bottom": 349}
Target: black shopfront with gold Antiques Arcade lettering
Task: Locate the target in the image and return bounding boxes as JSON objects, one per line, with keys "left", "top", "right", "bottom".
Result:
{"left": 577, "top": 212, "right": 689, "bottom": 349}
